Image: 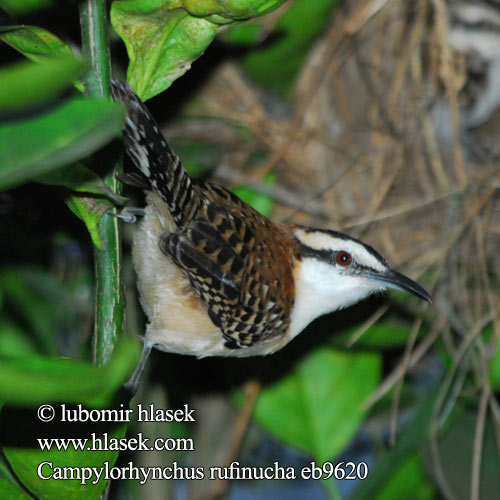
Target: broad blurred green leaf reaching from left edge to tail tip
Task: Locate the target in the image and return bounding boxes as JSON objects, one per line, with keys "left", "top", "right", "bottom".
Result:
{"left": 0, "top": 98, "right": 125, "bottom": 189}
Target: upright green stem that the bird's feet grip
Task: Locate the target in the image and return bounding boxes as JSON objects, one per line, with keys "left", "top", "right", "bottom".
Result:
{"left": 80, "top": 0, "right": 125, "bottom": 366}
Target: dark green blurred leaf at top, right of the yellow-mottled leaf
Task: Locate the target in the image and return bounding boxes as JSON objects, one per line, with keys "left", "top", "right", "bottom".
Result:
{"left": 239, "top": 0, "right": 339, "bottom": 94}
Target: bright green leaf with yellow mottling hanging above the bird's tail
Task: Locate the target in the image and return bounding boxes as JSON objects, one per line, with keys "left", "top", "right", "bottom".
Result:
{"left": 111, "top": 0, "right": 284, "bottom": 99}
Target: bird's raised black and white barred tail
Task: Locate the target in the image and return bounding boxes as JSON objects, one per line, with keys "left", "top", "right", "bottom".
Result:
{"left": 111, "top": 80, "right": 198, "bottom": 228}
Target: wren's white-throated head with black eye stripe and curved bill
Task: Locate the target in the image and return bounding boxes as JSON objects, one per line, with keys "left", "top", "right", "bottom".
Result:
{"left": 292, "top": 228, "right": 432, "bottom": 334}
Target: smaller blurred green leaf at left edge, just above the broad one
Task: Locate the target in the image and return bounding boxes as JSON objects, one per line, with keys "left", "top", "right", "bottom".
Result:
{"left": 0, "top": 56, "right": 81, "bottom": 111}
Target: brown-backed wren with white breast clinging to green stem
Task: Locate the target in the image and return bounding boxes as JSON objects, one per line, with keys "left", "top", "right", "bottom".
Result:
{"left": 112, "top": 80, "right": 432, "bottom": 390}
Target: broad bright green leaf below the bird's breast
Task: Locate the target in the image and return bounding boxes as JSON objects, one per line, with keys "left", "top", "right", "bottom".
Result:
{"left": 250, "top": 348, "right": 381, "bottom": 462}
